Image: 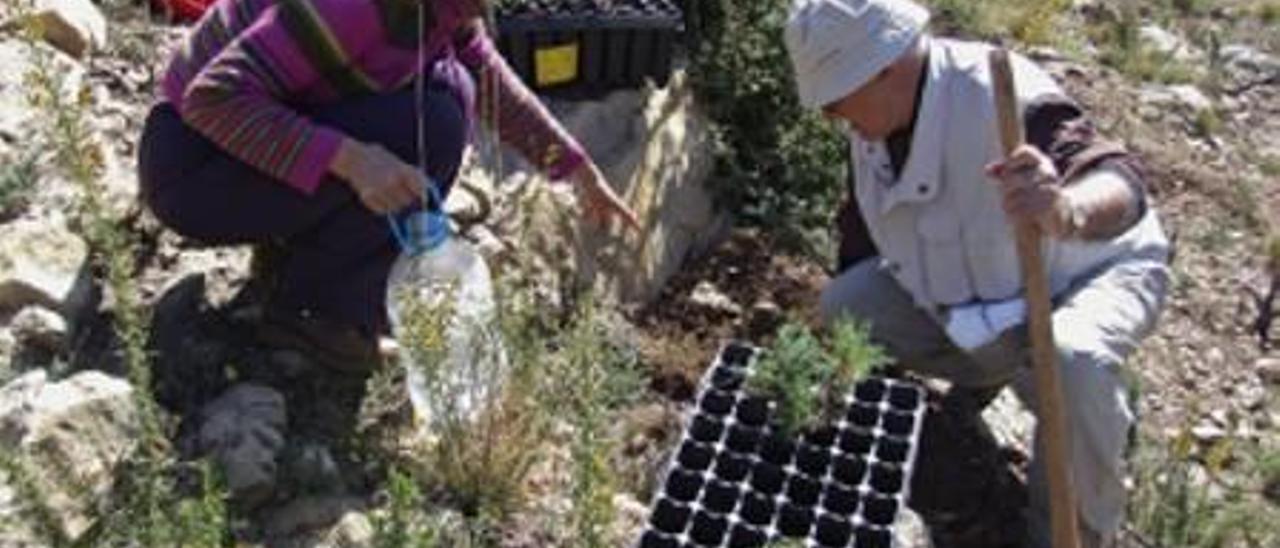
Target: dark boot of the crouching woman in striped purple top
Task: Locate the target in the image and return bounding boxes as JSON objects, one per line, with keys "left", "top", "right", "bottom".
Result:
{"left": 257, "top": 306, "right": 381, "bottom": 374}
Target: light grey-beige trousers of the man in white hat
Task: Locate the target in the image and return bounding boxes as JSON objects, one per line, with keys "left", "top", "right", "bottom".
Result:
{"left": 820, "top": 254, "right": 1169, "bottom": 548}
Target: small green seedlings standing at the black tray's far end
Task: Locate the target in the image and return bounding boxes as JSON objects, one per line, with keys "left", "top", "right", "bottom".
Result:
{"left": 746, "top": 320, "right": 888, "bottom": 433}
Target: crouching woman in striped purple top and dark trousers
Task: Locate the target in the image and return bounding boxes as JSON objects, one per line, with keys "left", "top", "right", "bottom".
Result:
{"left": 138, "top": 0, "right": 636, "bottom": 370}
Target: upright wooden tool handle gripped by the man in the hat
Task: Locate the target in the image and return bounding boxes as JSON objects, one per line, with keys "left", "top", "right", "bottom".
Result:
{"left": 991, "top": 49, "right": 1080, "bottom": 548}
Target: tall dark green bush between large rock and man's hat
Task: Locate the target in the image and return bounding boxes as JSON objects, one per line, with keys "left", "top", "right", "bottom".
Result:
{"left": 686, "top": 0, "right": 847, "bottom": 255}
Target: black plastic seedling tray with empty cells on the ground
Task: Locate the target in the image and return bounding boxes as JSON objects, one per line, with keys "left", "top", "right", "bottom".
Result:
{"left": 636, "top": 343, "right": 925, "bottom": 548}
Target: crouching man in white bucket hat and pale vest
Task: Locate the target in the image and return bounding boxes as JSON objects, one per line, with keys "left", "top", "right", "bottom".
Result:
{"left": 783, "top": 0, "right": 1169, "bottom": 547}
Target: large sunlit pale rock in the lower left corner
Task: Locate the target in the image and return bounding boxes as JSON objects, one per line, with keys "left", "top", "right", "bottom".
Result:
{"left": 0, "top": 370, "right": 138, "bottom": 538}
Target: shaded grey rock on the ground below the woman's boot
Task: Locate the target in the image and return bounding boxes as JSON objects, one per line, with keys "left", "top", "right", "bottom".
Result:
{"left": 198, "top": 383, "right": 287, "bottom": 507}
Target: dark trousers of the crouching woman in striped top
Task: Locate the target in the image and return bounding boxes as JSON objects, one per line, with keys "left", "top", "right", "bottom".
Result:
{"left": 138, "top": 79, "right": 470, "bottom": 333}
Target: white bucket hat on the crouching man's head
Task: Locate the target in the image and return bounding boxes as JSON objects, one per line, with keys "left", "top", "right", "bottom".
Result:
{"left": 783, "top": 0, "right": 929, "bottom": 109}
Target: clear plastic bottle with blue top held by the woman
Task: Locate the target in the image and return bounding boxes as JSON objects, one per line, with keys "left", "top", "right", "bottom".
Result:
{"left": 387, "top": 184, "right": 507, "bottom": 438}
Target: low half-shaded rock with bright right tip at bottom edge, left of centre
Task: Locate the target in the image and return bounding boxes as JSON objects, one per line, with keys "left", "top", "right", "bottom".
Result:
{"left": 264, "top": 497, "right": 372, "bottom": 545}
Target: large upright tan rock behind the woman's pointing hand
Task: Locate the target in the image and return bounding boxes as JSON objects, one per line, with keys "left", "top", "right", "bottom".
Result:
{"left": 477, "top": 73, "right": 731, "bottom": 303}
